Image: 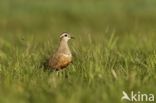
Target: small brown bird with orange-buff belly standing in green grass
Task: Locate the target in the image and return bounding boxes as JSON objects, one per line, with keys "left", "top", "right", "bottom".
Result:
{"left": 48, "top": 32, "right": 74, "bottom": 71}
